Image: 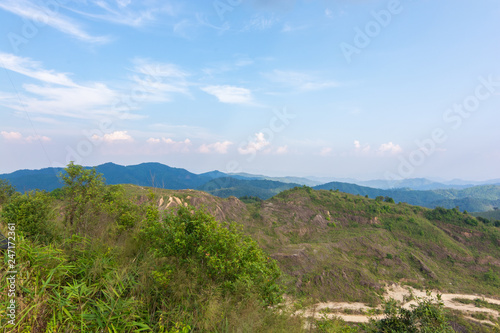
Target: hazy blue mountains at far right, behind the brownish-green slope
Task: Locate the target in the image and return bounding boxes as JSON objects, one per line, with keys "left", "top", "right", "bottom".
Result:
{"left": 314, "top": 182, "right": 500, "bottom": 212}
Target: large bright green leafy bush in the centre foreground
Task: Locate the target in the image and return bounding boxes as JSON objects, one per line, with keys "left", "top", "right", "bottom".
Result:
{"left": 143, "top": 207, "right": 281, "bottom": 304}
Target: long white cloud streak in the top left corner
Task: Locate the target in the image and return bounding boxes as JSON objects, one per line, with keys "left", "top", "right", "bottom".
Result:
{"left": 0, "top": 0, "right": 110, "bottom": 43}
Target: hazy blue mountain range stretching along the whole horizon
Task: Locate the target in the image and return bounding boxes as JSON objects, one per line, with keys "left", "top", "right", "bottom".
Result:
{"left": 0, "top": 163, "right": 500, "bottom": 212}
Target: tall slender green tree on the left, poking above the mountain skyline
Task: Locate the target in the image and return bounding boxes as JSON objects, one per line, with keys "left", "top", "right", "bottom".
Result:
{"left": 59, "top": 162, "right": 105, "bottom": 231}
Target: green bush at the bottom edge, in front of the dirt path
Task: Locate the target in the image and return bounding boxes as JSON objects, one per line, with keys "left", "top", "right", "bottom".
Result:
{"left": 365, "top": 293, "right": 454, "bottom": 333}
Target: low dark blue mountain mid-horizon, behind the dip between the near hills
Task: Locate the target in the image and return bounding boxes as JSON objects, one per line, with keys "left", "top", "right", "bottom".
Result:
{"left": 198, "top": 177, "right": 300, "bottom": 200}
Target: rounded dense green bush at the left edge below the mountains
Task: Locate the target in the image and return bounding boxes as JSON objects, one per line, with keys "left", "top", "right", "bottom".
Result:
{"left": 2, "top": 191, "right": 56, "bottom": 243}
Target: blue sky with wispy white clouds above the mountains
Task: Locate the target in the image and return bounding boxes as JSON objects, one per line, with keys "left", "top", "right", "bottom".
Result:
{"left": 0, "top": 0, "right": 500, "bottom": 180}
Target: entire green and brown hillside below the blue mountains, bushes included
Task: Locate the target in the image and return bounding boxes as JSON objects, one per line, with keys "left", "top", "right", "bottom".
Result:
{"left": 0, "top": 166, "right": 500, "bottom": 333}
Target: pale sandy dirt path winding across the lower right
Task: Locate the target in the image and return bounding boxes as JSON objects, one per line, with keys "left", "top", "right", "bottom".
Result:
{"left": 296, "top": 285, "right": 500, "bottom": 324}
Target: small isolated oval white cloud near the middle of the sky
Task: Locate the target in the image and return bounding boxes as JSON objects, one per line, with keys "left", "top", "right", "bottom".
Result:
{"left": 263, "top": 69, "right": 340, "bottom": 91}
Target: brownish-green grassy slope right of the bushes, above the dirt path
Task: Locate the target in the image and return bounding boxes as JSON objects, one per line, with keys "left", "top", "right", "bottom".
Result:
{"left": 122, "top": 188, "right": 500, "bottom": 303}
